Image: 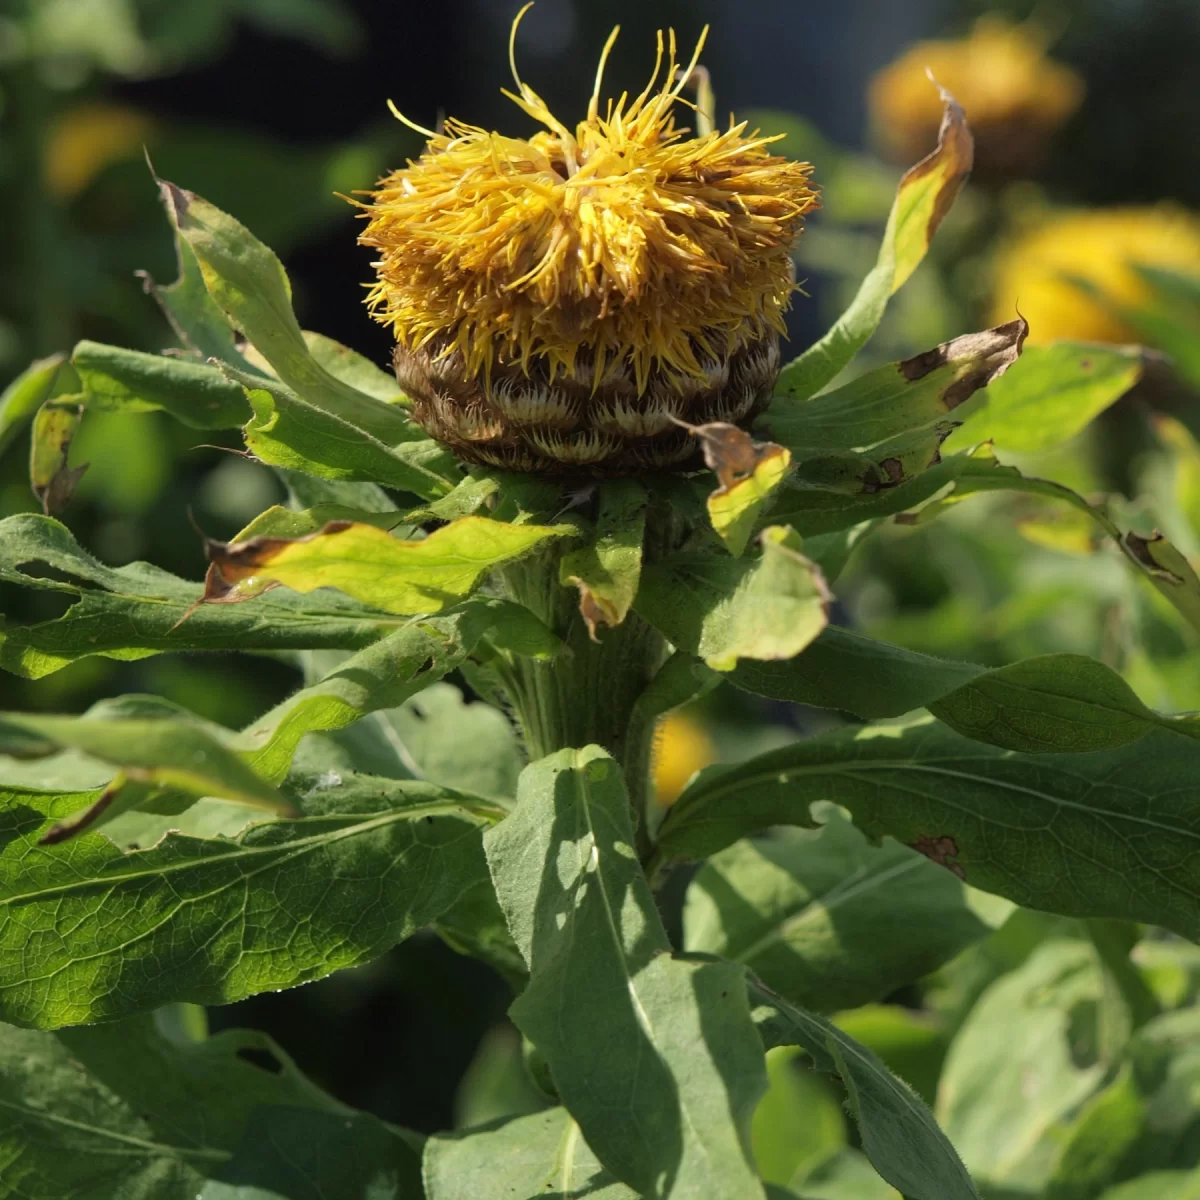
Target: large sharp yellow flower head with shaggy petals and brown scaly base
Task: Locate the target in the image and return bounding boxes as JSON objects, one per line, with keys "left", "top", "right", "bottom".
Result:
{"left": 350, "top": 6, "right": 817, "bottom": 469}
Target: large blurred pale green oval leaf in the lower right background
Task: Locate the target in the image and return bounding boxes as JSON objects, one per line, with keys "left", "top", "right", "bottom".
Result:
{"left": 937, "top": 938, "right": 1106, "bottom": 1195}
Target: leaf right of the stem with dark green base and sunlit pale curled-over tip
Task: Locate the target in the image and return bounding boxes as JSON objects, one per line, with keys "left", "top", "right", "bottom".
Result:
{"left": 635, "top": 526, "right": 832, "bottom": 671}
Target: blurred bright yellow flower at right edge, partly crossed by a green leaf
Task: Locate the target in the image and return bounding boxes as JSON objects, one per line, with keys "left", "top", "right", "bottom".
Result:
{"left": 992, "top": 205, "right": 1200, "bottom": 342}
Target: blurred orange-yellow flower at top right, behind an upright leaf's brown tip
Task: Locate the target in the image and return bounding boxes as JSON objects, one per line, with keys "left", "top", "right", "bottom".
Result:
{"left": 868, "top": 16, "right": 1084, "bottom": 179}
